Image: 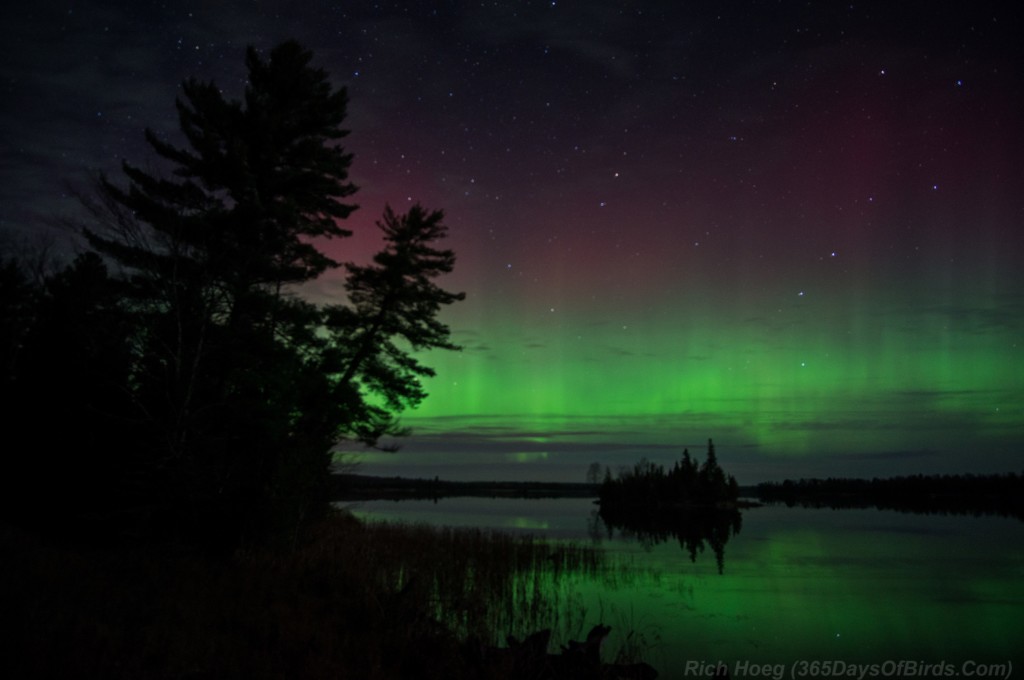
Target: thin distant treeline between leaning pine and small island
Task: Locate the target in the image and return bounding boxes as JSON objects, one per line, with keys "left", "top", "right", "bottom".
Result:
{"left": 331, "top": 474, "right": 597, "bottom": 501}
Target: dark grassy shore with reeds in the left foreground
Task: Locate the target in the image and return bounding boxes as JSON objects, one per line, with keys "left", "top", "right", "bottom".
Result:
{"left": 0, "top": 515, "right": 614, "bottom": 680}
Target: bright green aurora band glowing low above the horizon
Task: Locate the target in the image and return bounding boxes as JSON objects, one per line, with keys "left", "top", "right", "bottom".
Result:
{"left": 348, "top": 268, "right": 1024, "bottom": 483}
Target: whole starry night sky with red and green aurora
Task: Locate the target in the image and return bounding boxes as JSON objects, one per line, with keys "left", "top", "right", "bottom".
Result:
{"left": 0, "top": 0, "right": 1024, "bottom": 483}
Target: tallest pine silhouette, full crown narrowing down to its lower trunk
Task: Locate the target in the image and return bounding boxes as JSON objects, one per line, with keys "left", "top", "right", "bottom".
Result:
{"left": 86, "top": 41, "right": 355, "bottom": 466}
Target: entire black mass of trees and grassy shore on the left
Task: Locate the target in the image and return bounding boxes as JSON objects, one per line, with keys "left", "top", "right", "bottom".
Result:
{"left": 0, "top": 42, "right": 663, "bottom": 680}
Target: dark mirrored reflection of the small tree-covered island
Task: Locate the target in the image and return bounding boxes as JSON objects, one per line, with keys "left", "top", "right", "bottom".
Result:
{"left": 591, "top": 506, "right": 743, "bottom": 573}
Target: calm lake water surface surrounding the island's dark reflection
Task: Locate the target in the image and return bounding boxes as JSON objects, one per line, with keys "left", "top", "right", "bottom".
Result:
{"left": 350, "top": 498, "right": 1024, "bottom": 680}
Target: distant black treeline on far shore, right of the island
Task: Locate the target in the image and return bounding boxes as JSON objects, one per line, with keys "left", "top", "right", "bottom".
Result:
{"left": 757, "top": 472, "right": 1024, "bottom": 519}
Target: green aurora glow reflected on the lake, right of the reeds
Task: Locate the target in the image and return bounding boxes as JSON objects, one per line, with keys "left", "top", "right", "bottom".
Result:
{"left": 589, "top": 509, "right": 1024, "bottom": 670}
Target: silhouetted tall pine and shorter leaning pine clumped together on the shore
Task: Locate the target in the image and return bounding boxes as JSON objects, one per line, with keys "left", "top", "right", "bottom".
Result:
{"left": 5, "top": 41, "right": 463, "bottom": 544}
